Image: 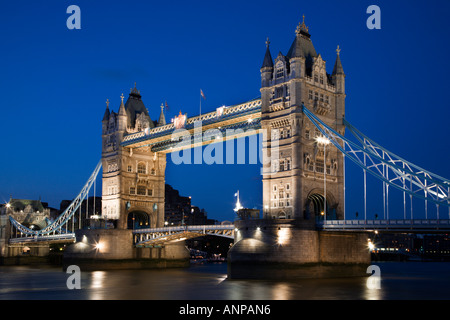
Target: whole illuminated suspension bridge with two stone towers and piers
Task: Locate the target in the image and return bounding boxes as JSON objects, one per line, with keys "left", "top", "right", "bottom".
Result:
{"left": 3, "top": 19, "right": 450, "bottom": 277}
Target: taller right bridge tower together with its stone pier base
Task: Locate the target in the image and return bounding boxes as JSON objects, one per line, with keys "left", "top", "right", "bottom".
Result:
{"left": 228, "top": 17, "right": 370, "bottom": 279}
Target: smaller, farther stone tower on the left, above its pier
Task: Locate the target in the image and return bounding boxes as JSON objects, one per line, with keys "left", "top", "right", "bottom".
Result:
{"left": 102, "top": 85, "right": 166, "bottom": 229}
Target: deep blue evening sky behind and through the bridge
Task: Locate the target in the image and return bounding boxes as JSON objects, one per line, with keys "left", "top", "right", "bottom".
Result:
{"left": 0, "top": 0, "right": 450, "bottom": 220}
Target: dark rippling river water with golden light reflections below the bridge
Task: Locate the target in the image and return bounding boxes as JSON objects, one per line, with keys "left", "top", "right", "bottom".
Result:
{"left": 0, "top": 262, "right": 450, "bottom": 300}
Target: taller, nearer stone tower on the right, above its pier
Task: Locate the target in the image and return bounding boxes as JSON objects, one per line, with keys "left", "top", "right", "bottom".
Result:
{"left": 261, "top": 17, "right": 345, "bottom": 222}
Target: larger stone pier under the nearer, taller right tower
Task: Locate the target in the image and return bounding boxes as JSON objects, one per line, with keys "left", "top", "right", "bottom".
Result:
{"left": 228, "top": 219, "right": 370, "bottom": 279}
